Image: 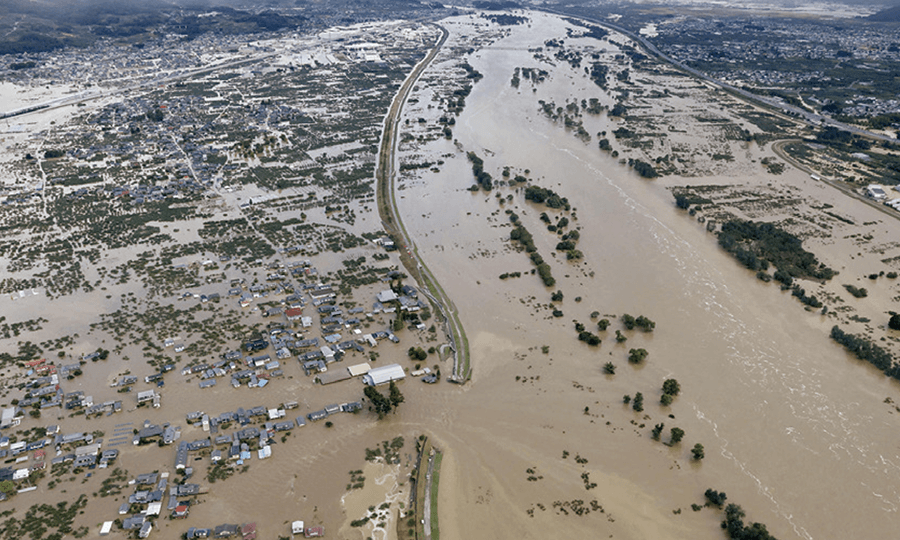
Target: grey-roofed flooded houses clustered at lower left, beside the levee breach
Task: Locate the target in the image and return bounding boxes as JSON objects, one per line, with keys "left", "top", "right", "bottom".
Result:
{"left": 0, "top": 262, "right": 424, "bottom": 539}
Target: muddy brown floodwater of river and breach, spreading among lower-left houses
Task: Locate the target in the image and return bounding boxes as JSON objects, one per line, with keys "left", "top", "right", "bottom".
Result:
{"left": 0, "top": 9, "right": 900, "bottom": 540}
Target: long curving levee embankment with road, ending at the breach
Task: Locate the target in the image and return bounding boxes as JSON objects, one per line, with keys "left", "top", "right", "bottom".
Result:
{"left": 375, "top": 25, "right": 470, "bottom": 383}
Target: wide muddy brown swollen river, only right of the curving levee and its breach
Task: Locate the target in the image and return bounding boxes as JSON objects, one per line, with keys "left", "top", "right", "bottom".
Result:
{"left": 399, "top": 11, "right": 900, "bottom": 539}
